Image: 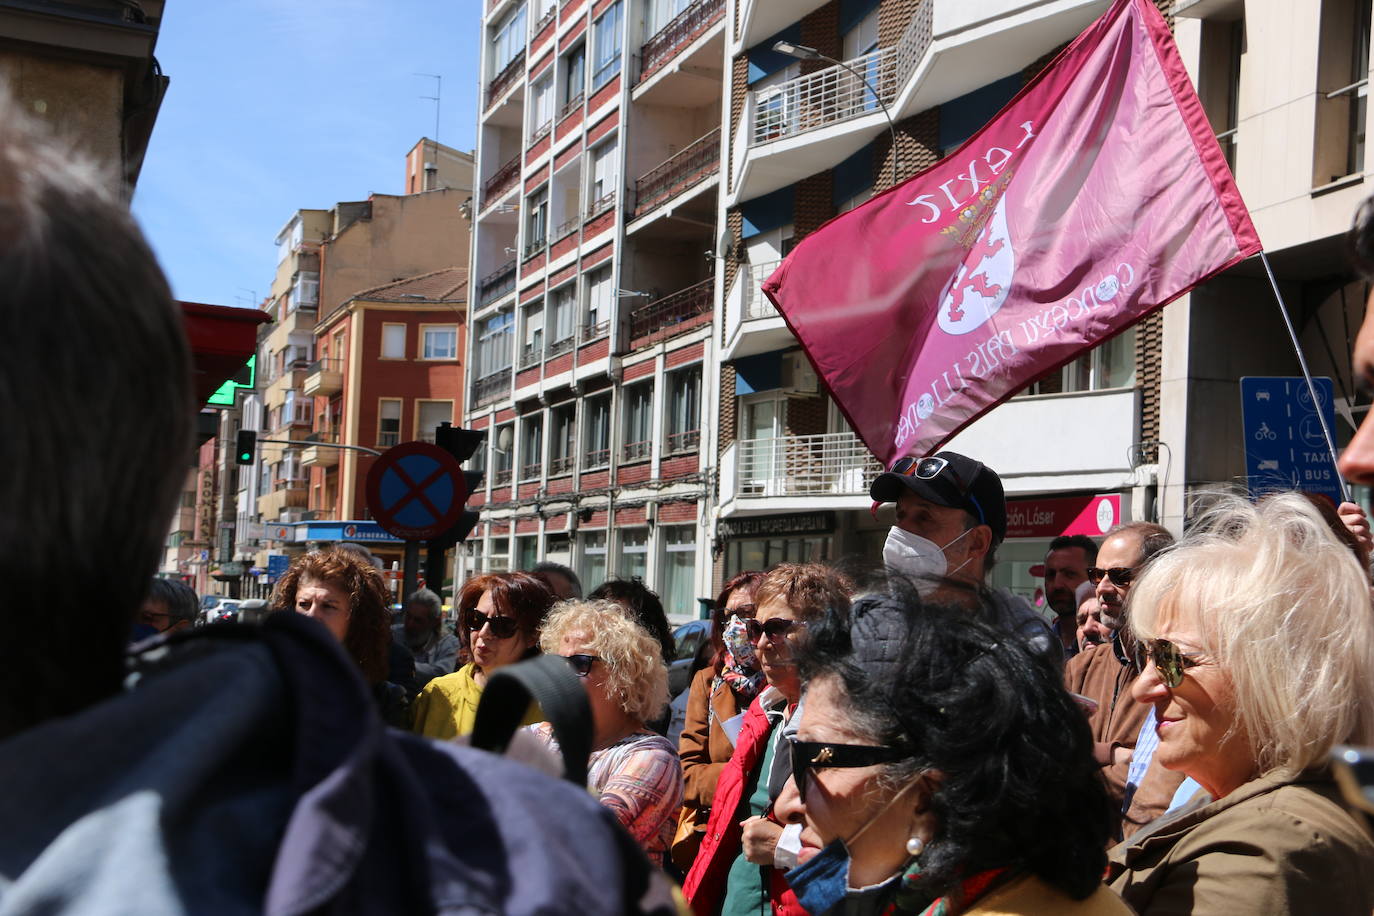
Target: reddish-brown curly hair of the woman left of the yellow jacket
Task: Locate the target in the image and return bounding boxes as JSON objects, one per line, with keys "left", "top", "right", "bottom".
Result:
{"left": 272, "top": 547, "right": 392, "bottom": 684}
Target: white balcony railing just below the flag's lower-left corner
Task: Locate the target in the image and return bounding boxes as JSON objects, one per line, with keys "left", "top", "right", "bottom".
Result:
{"left": 735, "top": 433, "right": 882, "bottom": 497}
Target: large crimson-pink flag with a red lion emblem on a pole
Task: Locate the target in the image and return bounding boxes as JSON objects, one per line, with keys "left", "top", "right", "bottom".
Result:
{"left": 763, "top": 0, "right": 1260, "bottom": 461}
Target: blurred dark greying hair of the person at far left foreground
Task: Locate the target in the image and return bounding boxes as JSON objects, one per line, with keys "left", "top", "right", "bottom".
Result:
{"left": 0, "top": 92, "right": 195, "bottom": 739}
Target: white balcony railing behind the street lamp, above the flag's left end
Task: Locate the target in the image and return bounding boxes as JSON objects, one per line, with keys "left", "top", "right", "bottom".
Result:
{"left": 750, "top": 46, "right": 901, "bottom": 144}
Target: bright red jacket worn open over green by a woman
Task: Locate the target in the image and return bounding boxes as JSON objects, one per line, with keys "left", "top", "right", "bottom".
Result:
{"left": 683, "top": 699, "right": 808, "bottom": 916}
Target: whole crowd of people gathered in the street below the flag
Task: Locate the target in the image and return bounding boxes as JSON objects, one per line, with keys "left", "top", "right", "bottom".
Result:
{"left": 10, "top": 87, "right": 1374, "bottom": 916}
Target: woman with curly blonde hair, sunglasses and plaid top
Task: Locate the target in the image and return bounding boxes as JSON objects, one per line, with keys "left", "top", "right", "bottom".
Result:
{"left": 533, "top": 600, "right": 683, "bottom": 865}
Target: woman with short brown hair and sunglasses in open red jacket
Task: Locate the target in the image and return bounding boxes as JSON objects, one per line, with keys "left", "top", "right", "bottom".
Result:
{"left": 683, "top": 563, "right": 852, "bottom": 916}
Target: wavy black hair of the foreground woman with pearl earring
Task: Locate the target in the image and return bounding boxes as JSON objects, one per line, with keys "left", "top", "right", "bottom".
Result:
{"left": 797, "top": 582, "right": 1116, "bottom": 900}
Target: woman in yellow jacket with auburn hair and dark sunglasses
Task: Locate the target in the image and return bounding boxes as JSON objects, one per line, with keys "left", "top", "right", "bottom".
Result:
{"left": 412, "top": 573, "right": 554, "bottom": 739}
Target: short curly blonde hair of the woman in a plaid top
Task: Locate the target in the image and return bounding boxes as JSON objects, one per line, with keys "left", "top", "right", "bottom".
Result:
{"left": 539, "top": 600, "right": 668, "bottom": 722}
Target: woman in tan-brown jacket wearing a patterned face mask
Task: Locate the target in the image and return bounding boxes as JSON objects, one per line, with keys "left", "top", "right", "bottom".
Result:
{"left": 673, "top": 571, "right": 764, "bottom": 873}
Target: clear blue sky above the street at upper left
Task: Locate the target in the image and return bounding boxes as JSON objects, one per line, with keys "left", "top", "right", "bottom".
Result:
{"left": 133, "top": 0, "right": 481, "bottom": 305}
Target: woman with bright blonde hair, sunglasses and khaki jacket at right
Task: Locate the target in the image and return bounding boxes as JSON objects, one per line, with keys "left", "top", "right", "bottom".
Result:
{"left": 1107, "top": 493, "right": 1374, "bottom": 915}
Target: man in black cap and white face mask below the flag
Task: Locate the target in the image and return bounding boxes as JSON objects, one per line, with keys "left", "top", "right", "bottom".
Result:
{"left": 868, "top": 452, "right": 1063, "bottom": 663}
